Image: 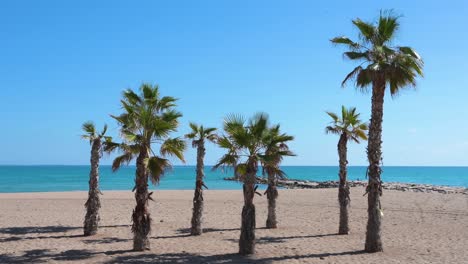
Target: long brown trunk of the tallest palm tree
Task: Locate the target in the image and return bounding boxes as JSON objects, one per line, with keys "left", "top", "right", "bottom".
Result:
{"left": 365, "top": 78, "right": 385, "bottom": 252}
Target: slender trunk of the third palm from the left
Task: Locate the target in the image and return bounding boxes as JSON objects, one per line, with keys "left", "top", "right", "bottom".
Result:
{"left": 190, "top": 141, "right": 205, "bottom": 236}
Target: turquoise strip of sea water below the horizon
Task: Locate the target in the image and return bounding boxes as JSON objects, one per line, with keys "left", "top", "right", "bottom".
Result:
{"left": 0, "top": 166, "right": 468, "bottom": 193}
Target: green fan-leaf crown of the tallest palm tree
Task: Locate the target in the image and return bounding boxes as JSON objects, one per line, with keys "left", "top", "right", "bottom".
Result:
{"left": 331, "top": 12, "right": 424, "bottom": 95}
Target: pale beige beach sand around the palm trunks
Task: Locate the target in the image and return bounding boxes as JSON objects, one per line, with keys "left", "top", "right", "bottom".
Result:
{"left": 0, "top": 187, "right": 468, "bottom": 263}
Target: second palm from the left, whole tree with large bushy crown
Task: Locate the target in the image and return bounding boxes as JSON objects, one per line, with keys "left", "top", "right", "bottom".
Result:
{"left": 106, "top": 84, "right": 186, "bottom": 251}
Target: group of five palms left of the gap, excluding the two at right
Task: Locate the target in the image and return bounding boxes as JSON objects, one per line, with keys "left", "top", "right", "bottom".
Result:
{"left": 83, "top": 84, "right": 293, "bottom": 254}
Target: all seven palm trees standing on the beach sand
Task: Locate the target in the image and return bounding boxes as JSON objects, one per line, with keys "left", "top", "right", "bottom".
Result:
{"left": 83, "top": 12, "right": 423, "bottom": 255}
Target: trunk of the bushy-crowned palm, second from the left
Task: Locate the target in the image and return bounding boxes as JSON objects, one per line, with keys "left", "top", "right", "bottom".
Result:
{"left": 132, "top": 147, "right": 151, "bottom": 251}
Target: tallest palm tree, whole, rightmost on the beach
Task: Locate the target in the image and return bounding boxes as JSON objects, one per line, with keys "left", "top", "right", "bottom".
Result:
{"left": 331, "top": 12, "right": 423, "bottom": 252}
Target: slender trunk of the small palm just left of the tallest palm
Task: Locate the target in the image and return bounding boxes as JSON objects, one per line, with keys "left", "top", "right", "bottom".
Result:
{"left": 338, "top": 133, "right": 350, "bottom": 235}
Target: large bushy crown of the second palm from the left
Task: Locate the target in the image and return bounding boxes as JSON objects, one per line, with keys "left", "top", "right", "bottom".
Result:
{"left": 107, "top": 84, "right": 186, "bottom": 183}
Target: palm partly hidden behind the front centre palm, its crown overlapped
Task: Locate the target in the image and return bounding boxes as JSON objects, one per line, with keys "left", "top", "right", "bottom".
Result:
{"left": 262, "top": 125, "right": 294, "bottom": 228}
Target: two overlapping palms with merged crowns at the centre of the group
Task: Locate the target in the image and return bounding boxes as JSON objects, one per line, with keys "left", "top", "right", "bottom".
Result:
{"left": 213, "top": 113, "right": 294, "bottom": 255}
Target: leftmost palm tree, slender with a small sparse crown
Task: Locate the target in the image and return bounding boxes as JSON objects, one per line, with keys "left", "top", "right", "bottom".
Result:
{"left": 81, "top": 121, "right": 112, "bottom": 236}
